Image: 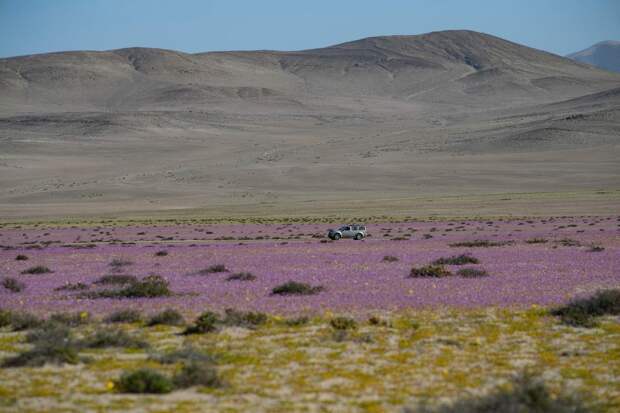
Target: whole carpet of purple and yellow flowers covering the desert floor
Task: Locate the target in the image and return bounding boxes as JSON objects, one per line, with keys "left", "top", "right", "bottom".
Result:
{"left": 0, "top": 217, "right": 620, "bottom": 412}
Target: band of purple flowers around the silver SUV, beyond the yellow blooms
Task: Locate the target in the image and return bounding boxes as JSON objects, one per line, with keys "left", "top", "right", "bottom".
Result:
{"left": 0, "top": 217, "right": 620, "bottom": 315}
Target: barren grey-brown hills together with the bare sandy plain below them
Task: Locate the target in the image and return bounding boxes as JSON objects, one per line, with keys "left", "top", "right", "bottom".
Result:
{"left": 0, "top": 30, "right": 620, "bottom": 217}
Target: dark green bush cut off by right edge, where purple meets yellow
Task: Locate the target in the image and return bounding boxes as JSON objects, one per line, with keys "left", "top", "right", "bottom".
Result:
{"left": 551, "top": 289, "right": 620, "bottom": 327}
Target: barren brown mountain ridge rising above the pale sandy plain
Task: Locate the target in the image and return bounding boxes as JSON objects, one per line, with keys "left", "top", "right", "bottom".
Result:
{"left": 0, "top": 31, "right": 618, "bottom": 112}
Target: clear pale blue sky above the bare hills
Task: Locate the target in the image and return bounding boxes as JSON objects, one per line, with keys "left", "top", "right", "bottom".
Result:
{"left": 0, "top": 0, "right": 620, "bottom": 57}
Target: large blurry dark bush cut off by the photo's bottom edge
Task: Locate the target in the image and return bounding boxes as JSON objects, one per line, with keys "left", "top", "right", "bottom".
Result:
{"left": 405, "top": 373, "right": 598, "bottom": 413}
